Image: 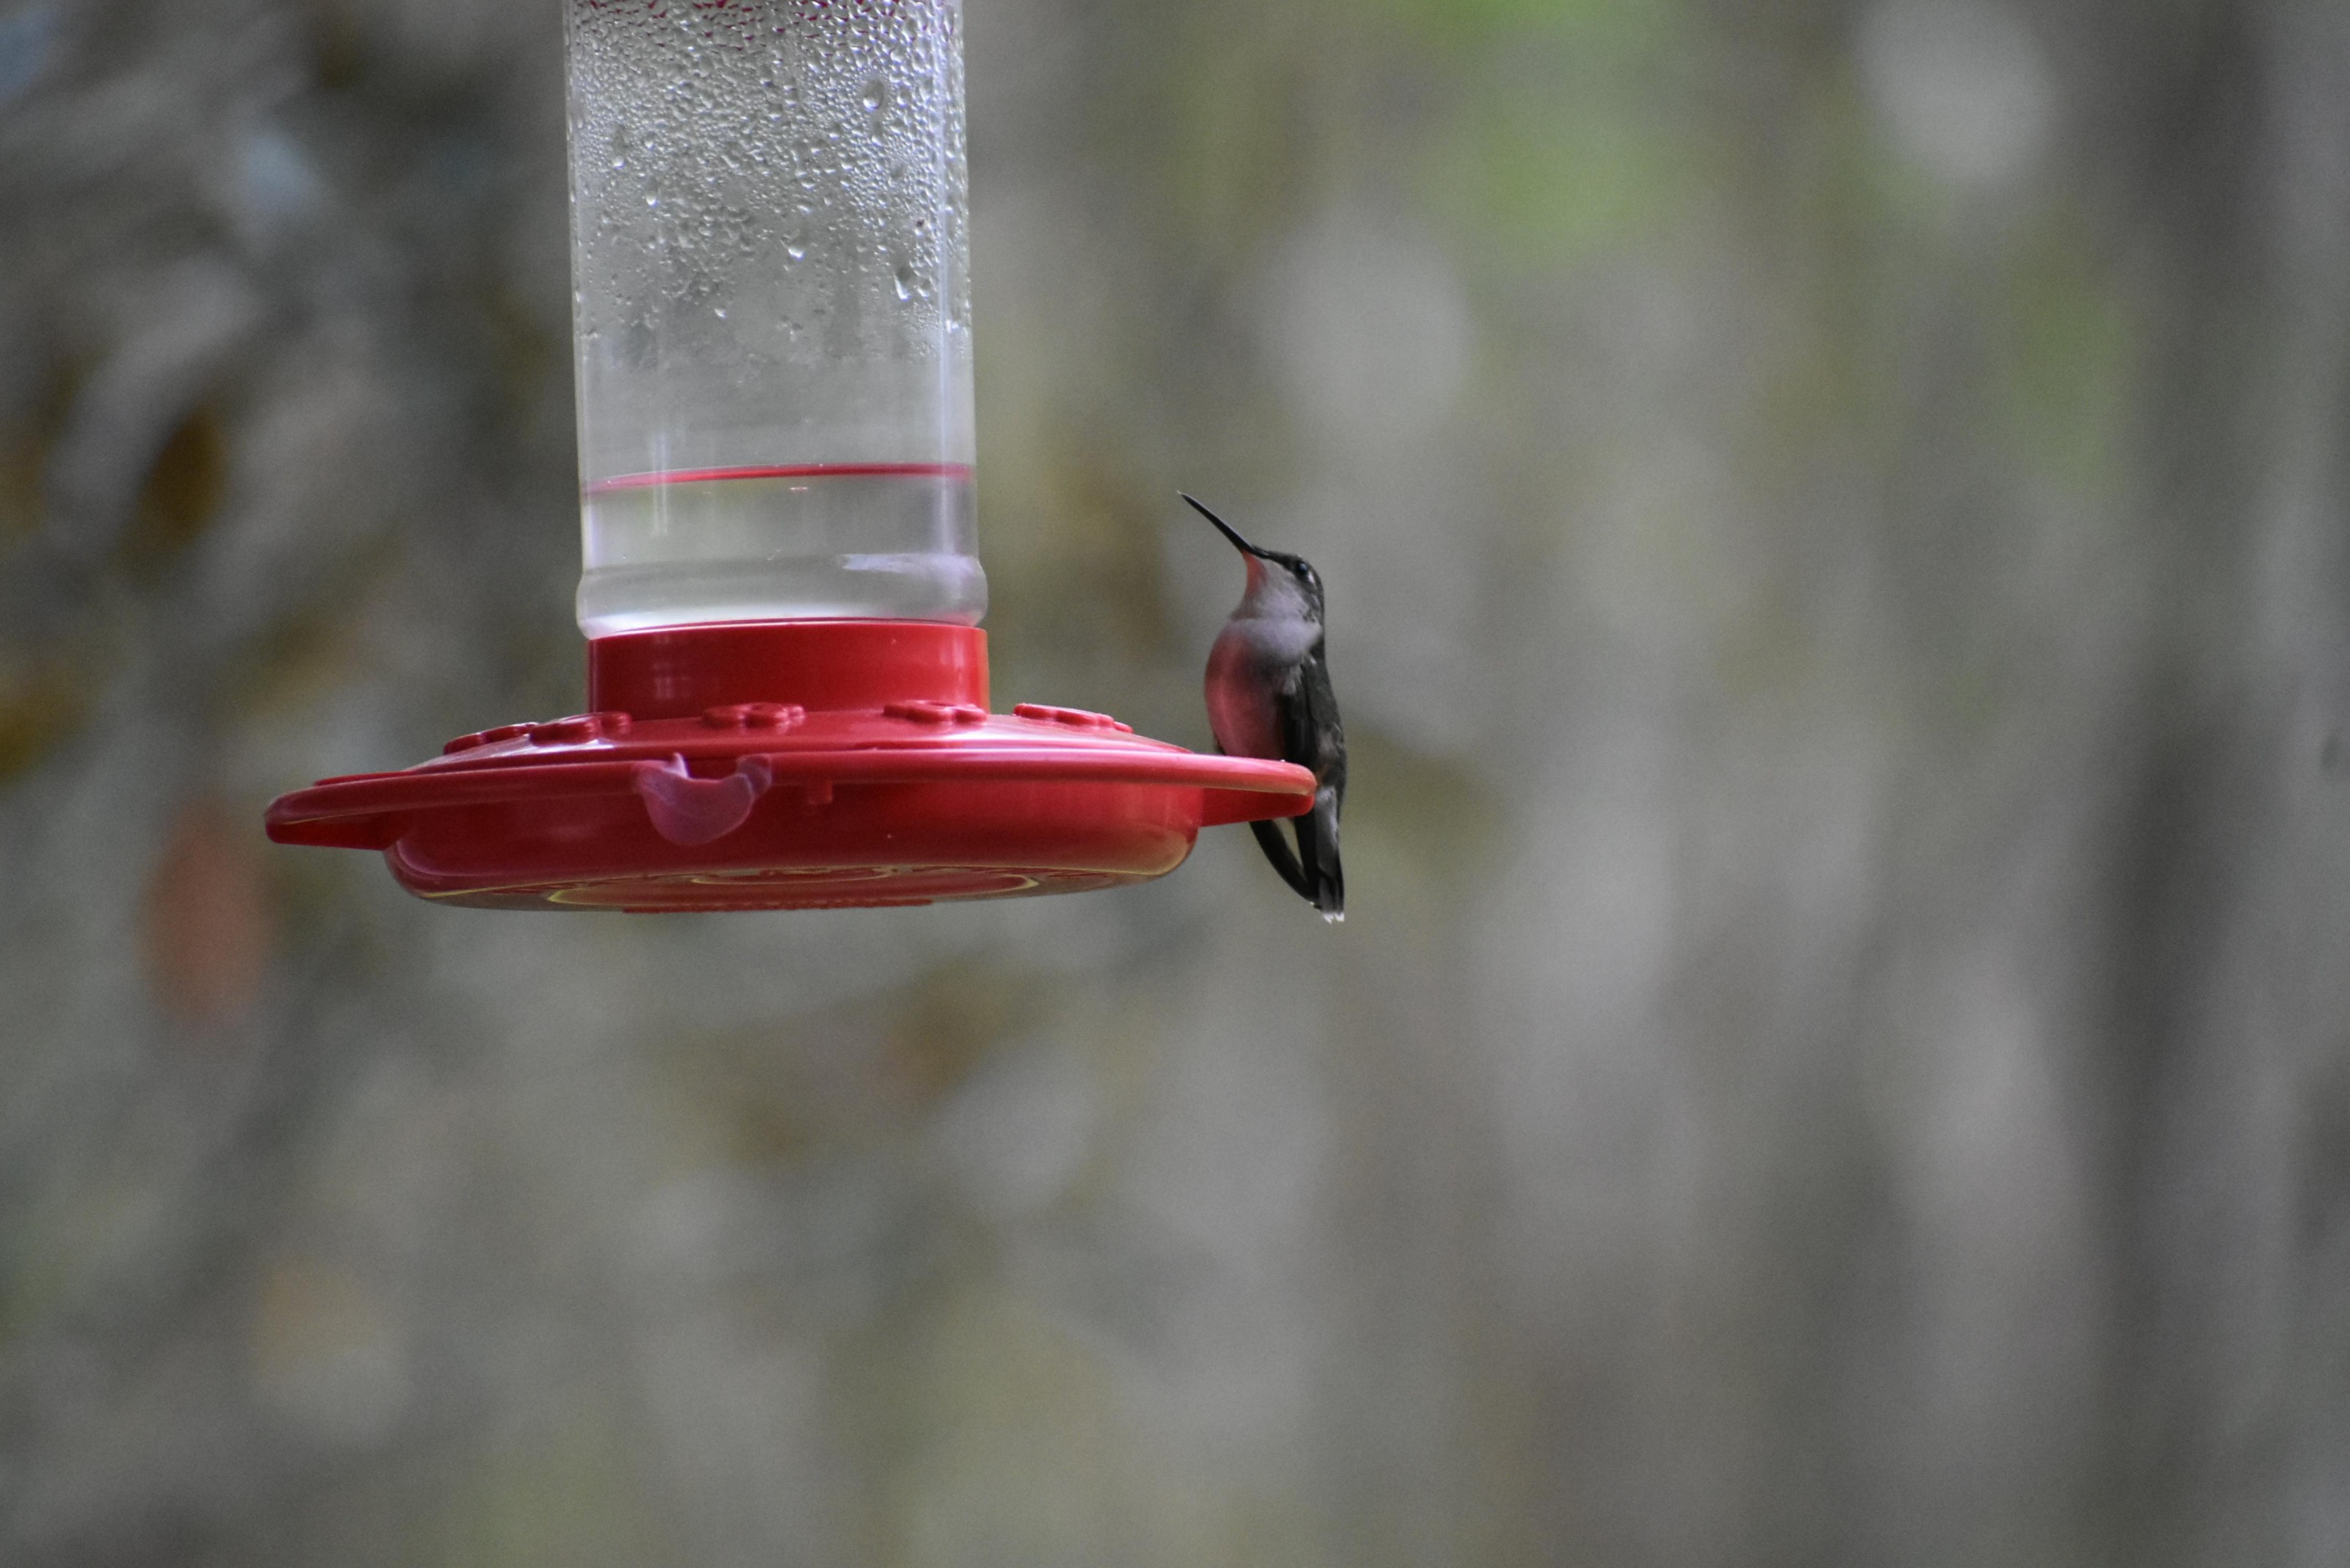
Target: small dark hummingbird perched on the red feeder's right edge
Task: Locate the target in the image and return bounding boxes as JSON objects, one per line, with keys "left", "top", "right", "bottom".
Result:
{"left": 1177, "top": 491, "right": 1347, "bottom": 924}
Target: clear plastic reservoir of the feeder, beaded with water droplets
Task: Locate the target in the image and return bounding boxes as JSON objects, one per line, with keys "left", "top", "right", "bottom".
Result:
{"left": 568, "top": 0, "right": 987, "bottom": 637}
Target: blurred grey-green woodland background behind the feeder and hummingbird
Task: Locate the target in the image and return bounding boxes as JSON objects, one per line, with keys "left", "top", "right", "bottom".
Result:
{"left": 0, "top": 0, "right": 2350, "bottom": 1568}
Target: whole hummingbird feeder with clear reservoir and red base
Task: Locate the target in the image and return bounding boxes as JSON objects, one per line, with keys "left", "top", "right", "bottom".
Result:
{"left": 268, "top": 0, "right": 1314, "bottom": 912}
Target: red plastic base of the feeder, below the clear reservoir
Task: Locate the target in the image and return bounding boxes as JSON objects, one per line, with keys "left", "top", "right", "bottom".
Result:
{"left": 268, "top": 621, "right": 1314, "bottom": 914}
